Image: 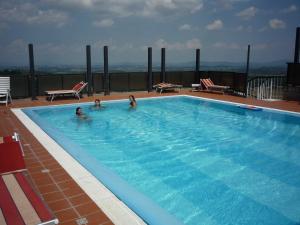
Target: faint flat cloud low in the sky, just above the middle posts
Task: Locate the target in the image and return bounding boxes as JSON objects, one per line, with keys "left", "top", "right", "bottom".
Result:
{"left": 154, "top": 38, "right": 202, "bottom": 50}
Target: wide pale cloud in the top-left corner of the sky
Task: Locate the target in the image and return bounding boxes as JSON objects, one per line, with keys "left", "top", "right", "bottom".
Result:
{"left": 0, "top": 2, "right": 69, "bottom": 27}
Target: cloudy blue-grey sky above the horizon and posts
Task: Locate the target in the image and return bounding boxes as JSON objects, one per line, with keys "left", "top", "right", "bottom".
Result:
{"left": 0, "top": 0, "right": 300, "bottom": 66}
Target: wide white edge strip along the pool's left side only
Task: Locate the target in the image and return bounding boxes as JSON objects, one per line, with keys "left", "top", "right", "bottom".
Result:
{"left": 11, "top": 108, "right": 146, "bottom": 225}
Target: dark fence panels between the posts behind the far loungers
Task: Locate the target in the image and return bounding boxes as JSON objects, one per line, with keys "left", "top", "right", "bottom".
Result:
{"left": 1, "top": 71, "right": 246, "bottom": 98}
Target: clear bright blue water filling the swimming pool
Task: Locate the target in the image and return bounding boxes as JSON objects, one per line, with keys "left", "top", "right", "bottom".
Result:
{"left": 24, "top": 96, "right": 300, "bottom": 225}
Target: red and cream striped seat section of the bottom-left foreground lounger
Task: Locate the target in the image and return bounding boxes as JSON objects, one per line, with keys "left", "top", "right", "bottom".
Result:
{"left": 0, "top": 172, "right": 58, "bottom": 225}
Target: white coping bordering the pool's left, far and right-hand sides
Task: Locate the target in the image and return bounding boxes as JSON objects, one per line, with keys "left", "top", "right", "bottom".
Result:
{"left": 11, "top": 95, "right": 300, "bottom": 224}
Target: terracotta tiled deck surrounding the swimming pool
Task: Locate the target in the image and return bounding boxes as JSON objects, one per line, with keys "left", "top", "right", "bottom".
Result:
{"left": 0, "top": 90, "right": 300, "bottom": 225}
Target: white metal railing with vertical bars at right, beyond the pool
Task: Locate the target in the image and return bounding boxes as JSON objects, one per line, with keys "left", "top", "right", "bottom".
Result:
{"left": 247, "top": 76, "right": 286, "bottom": 100}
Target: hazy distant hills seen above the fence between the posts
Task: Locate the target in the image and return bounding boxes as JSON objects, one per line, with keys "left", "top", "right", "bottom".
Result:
{"left": 0, "top": 60, "right": 287, "bottom": 75}
